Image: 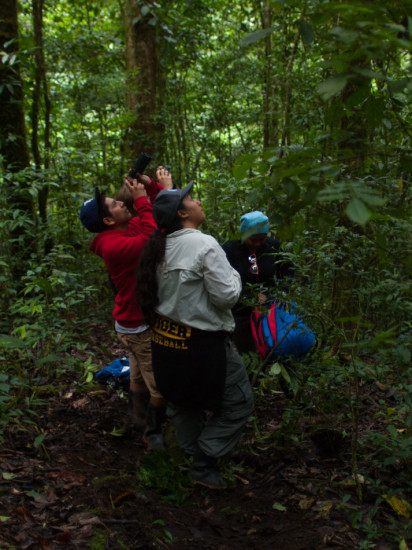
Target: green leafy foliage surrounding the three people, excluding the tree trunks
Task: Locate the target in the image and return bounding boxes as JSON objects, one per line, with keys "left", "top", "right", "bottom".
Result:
{"left": 0, "top": 0, "right": 412, "bottom": 548}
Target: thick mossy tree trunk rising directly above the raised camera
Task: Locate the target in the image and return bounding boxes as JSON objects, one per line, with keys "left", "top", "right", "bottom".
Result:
{"left": 125, "top": 0, "right": 162, "bottom": 166}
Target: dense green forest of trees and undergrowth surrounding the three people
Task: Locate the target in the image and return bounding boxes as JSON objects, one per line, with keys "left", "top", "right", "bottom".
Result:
{"left": 0, "top": 0, "right": 412, "bottom": 550}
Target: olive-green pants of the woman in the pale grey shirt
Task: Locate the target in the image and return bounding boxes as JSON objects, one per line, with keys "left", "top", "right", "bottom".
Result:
{"left": 168, "top": 338, "right": 253, "bottom": 458}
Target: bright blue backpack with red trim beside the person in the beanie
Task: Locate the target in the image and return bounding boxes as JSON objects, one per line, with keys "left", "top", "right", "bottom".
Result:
{"left": 250, "top": 301, "right": 316, "bottom": 359}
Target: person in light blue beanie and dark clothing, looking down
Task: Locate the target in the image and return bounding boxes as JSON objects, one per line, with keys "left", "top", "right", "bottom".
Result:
{"left": 223, "top": 210, "right": 294, "bottom": 353}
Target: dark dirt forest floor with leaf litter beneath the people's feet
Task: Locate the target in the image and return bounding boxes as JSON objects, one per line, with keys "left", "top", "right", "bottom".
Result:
{"left": 0, "top": 330, "right": 402, "bottom": 550}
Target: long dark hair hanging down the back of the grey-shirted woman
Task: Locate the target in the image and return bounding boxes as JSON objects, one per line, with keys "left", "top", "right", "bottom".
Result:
{"left": 136, "top": 214, "right": 182, "bottom": 326}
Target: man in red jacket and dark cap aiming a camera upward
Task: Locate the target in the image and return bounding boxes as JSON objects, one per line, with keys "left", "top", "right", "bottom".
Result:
{"left": 80, "top": 169, "right": 172, "bottom": 449}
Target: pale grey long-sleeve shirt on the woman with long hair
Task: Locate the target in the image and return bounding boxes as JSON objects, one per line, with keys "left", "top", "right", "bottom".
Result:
{"left": 156, "top": 229, "right": 242, "bottom": 332}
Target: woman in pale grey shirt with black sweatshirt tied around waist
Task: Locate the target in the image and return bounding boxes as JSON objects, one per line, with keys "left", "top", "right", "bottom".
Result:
{"left": 137, "top": 182, "right": 253, "bottom": 488}
